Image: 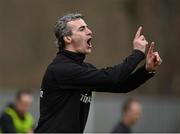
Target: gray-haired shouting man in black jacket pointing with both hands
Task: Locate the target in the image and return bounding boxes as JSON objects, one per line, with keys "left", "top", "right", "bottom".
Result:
{"left": 35, "top": 13, "right": 161, "bottom": 132}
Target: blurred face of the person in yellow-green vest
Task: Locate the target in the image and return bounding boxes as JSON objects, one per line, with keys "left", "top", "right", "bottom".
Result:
{"left": 16, "top": 94, "right": 33, "bottom": 114}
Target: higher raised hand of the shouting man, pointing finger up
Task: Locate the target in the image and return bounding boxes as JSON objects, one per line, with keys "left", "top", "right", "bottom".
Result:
{"left": 133, "top": 26, "right": 148, "bottom": 53}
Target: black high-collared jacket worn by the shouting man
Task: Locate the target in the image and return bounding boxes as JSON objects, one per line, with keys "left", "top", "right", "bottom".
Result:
{"left": 35, "top": 50, "right": 153, "bottom": 132}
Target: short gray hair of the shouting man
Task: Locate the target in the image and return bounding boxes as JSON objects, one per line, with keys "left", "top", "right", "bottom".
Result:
{"left": 54, "top": 13, "right": 83, "bottom": 50}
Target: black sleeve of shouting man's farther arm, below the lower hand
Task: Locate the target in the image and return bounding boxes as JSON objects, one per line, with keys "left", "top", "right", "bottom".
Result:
{"left": 94, "top": 66, "right": 155, "bottom": 93}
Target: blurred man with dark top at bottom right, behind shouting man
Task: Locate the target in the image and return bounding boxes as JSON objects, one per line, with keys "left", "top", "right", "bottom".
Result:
{"left": 112, "top": 98, "right": 142, "bottom": 133}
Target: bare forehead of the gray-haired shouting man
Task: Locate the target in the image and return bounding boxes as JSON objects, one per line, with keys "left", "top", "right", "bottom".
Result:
{"left": 67, "top": 19, "right": 87, "bottom": 29}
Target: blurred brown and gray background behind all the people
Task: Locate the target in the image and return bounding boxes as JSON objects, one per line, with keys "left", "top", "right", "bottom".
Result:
{"left": 0, "top": 0, "right": 180, "bottom": 132}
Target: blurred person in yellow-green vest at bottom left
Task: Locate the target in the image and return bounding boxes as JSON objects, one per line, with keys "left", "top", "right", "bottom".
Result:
{"left": 0, "top": 90, "right": 34, "bottom": 133}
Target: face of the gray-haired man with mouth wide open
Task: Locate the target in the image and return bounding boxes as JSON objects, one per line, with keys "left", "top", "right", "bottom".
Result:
{"left": 66, "top": 19, "right": 92, "bottom": 54}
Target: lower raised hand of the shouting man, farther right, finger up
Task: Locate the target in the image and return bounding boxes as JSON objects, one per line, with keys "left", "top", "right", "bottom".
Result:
{"left": 146, "top": 42, "right": 162, "bottom": 72}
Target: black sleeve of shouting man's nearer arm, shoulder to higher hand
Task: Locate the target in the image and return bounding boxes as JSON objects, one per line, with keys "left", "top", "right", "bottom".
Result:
{"left": 52, "top": 50, "right": 145, "bottom": 91}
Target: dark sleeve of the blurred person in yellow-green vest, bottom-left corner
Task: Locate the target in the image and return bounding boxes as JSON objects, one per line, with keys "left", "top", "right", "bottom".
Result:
{"left": 0, "top": 113, "right": 16, "bottom": 133}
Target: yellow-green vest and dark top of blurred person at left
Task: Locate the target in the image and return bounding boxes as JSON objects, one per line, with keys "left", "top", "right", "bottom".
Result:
{"left": 0, "top": 104, "right": 33, "bottom": 133}
